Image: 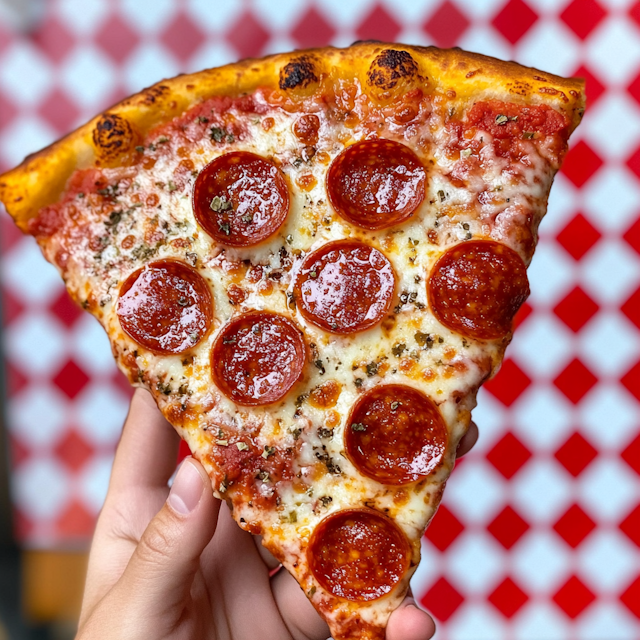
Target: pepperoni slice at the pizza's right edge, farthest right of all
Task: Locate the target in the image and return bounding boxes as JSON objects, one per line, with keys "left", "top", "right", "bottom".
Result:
{"left": 427, "top": 240, "right": 529, "bottom": 340}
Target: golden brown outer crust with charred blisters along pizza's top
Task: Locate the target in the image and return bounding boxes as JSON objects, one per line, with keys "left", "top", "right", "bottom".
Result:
{"left": 0, "top": 41, "right": 585, "bottom": 231}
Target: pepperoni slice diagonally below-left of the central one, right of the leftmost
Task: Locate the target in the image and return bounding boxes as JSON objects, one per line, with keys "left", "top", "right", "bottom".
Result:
{"left": 211, "top": 311, "right": 306, "bottom": 406}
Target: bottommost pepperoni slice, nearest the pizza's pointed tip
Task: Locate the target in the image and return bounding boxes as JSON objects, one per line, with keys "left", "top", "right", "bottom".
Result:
{"left": 307, "top": 509, "right": 410, "bottom": 602}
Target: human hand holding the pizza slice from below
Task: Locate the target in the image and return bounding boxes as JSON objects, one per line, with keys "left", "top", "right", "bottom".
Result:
{"left": 77, "top": 390, "right": 474, "bottom": 640}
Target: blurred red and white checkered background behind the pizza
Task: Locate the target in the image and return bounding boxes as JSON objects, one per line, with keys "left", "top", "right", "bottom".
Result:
{"left": 0, "top": 0, "right": 640, "bottom": 640}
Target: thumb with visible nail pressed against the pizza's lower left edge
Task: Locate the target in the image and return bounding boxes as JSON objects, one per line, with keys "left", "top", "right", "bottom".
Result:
{"left": 120, "top": 458, "right": 220, "bottom": 617}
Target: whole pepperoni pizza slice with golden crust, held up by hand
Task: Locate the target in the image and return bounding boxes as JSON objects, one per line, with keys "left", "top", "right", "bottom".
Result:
{"left": 0, "top": 42, "right": 584, "bottom": 640}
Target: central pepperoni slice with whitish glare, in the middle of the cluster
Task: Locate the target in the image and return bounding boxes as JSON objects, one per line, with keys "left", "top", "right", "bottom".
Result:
{"left": 294, "top": 240, "right": 395, "bottom": 334}
